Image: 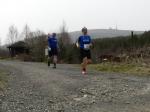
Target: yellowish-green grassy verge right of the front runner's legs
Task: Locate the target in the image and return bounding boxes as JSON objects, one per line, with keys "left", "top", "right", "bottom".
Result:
{"left": 89, "top": 63, "right": 150, "bottom": 75}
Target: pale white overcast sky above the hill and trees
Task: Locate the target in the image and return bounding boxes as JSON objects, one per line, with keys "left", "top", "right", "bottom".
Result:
{"left": 0, "top": 0, "right": 150, "bottom": 43}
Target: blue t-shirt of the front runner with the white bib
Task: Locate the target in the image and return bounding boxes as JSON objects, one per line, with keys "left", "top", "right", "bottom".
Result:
{"left": 78, "top": 35, "right": 91, "bottom": 49}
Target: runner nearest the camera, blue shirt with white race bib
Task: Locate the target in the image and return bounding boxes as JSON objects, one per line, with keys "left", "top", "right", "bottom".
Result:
{"left": 76, "top": 27, "right": 92, "bottom": 74}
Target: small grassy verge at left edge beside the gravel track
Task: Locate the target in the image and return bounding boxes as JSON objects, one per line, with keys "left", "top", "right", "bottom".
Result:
{"left": 0, "top": 70, "right": 8, "bottom": 90}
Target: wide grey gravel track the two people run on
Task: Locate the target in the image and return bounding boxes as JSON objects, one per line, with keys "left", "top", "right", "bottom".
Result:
{"left": 0, "top": 61, "right": 150, "bottom": 112}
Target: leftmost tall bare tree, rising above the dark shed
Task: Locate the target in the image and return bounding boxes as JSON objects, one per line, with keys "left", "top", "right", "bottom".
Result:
{"left": 8, "top": 25, "right": 18, "bottom": 44}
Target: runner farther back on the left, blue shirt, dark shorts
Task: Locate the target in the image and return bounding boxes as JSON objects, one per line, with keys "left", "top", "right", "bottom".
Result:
{"left": 48, "top": 33, "right": 58, "bottom": 68}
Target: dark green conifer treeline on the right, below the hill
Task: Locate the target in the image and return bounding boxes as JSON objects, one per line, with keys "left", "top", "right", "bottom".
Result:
{"left": 93, "top": 31, "right": 150, "bottom": 54}
